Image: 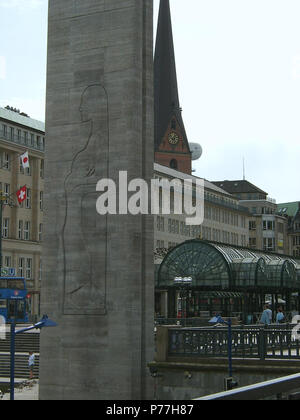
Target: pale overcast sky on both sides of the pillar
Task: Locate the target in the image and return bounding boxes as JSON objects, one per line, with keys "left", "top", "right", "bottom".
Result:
{"left": 0, "top": 0, "right": 300, "bottom": 203}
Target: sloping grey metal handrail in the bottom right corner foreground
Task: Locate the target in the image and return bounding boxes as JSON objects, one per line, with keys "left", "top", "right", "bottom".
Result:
{"left": 195, "top": 373, "right": 300, "bottom": 401}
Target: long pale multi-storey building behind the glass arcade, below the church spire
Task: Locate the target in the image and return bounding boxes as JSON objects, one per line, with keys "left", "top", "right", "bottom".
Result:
{"left": 154, "top": 163, "right": 250, "bottom": 254}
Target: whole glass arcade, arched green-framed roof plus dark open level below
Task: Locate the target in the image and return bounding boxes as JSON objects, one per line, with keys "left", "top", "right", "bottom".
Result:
{"left": 156, "top": 239, "right": 300, "bottom": 322}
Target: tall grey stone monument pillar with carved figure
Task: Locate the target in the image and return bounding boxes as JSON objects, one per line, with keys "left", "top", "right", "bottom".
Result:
{"left": 40, "top": 0, "right": 154, "bottom": 400}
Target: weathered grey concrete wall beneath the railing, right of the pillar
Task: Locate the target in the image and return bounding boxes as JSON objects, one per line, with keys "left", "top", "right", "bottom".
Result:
{"left": 149, "top": 358, "right": 300, "bottom": 401}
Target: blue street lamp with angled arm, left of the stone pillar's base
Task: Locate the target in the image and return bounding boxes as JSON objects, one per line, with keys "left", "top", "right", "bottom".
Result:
{"left": 10, "top": 315, "right": 57, "bottom": 401}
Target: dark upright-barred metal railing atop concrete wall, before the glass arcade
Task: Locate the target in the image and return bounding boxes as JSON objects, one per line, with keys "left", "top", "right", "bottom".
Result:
{"left": 168, "top": 325, "right": 300, "bottom": 360}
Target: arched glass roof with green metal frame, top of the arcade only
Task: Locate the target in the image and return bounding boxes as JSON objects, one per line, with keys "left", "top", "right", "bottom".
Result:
{"left": 156, "top": 239, "right": 300, "bottom": 292}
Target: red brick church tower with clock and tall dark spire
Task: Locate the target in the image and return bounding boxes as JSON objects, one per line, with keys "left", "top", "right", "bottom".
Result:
{"left": 154, "top": 0, "right": 192, "bottom": 174}
